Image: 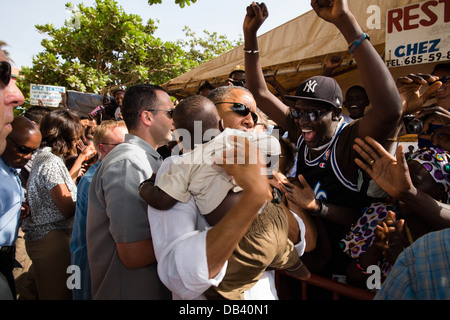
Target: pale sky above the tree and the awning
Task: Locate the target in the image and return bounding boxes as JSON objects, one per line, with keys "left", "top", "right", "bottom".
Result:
{"left": 0, "top": 0, "right": 311, "bottom": 68}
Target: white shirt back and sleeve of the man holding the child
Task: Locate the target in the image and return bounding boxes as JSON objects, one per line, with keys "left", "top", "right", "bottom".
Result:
{"left": 148, "top": 158, "right": 227, "bottom": 300}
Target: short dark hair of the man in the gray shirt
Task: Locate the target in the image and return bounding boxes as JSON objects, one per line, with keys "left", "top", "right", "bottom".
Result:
{"left": 121, "top": 83, "right": 166, "bottom": 130}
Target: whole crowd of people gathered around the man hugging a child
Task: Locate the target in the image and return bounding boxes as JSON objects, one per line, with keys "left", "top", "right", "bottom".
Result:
{"left": 0, "top": 0, "right": 450, "bottom": 300}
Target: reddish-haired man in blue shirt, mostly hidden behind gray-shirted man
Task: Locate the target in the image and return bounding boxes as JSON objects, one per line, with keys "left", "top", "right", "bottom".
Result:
{"left": 70, "top": 120, "right": 128, "bottom": 300}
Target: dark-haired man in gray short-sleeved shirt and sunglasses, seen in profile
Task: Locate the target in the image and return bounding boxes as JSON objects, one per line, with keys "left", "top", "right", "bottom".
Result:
{"left": 86, "top": 84, "right": 174, "bottom": 300}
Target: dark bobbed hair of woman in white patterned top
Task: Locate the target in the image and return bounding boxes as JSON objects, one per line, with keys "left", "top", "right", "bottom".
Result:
{"left": 40, "top": 109, "right": 83, "bottom": 156}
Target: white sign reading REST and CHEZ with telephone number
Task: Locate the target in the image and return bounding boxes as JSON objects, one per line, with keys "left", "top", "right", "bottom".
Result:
{"left": 385, "top": 0, "right": 450, "bottom": 67}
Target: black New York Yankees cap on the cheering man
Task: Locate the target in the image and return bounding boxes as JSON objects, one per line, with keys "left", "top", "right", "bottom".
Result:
{"left": 284, "top": 76, "right": 343, "bottom": 108}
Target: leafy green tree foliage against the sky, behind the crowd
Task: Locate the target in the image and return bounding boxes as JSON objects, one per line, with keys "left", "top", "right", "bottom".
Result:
{"left": 20, "top": 0, "right": 241, "bottom": 101}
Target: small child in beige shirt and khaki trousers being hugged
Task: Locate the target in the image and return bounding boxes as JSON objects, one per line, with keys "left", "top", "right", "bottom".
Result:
{"left": 139, "top": 96, "right": 309, "bottom": 300}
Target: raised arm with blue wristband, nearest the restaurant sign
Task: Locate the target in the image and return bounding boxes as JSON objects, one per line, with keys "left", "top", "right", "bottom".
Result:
{"left": 311, "top": 0, "right": 402, "bottom": 141}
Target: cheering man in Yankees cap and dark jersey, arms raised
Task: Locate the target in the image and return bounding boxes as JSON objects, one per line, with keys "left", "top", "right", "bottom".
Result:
{"left": 244, "top": 0, "right": 402, "bottom": 275}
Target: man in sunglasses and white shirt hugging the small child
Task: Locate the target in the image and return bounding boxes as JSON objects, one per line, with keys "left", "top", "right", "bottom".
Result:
{"left": 148, "top": 86, "right": 305, "bottom": 300}
